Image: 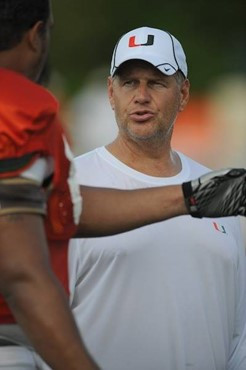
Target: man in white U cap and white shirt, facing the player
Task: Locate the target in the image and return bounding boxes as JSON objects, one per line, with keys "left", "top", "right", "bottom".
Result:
{"left": 70, "top": 27, "right": 246, "bottom": 370}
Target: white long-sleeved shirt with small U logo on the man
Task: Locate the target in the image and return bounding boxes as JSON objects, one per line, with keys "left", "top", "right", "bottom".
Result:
{"left": 69, "top": 147, "right": 246, "bottom": 370}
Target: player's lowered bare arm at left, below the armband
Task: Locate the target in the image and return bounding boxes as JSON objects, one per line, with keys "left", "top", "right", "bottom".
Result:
{"left": 0, "top": 214, "right": 98, "bottom": 370}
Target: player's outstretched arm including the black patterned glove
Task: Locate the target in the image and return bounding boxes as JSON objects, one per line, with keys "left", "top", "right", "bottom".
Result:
{"left": 77, "top": 169, "right": 246, "bottom": 237}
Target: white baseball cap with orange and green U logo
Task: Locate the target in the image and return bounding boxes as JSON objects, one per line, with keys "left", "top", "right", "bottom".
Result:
{"left": 110, "top": 27, "right": 188, "bottom": 77}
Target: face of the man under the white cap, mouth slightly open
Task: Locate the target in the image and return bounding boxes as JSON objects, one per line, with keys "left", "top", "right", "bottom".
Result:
{"left": 108, "top": 60, "right": 189, "bottom": 143}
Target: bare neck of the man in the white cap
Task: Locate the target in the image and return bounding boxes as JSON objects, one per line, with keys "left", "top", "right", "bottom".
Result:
{"left": 106, "top": 136, "right": 182, "bottom": 177}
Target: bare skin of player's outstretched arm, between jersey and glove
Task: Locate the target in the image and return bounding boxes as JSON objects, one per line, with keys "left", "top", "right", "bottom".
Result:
{"left": 76, "top": 185, "right": 188, "bottom": 237}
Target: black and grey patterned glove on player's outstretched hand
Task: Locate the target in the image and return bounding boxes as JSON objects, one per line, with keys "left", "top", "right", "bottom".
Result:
{"left": 182, "top": 168, "right": 246, "bottom": 218}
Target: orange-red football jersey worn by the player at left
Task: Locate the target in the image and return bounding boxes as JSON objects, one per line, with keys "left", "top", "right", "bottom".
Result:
{"left": 0, "top": 69, "right": 81, "bottom": 324}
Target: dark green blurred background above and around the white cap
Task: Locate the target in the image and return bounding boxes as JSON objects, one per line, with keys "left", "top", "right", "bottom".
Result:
{"left": 51, "top": 0, "right": 246, "bottom": 94}
